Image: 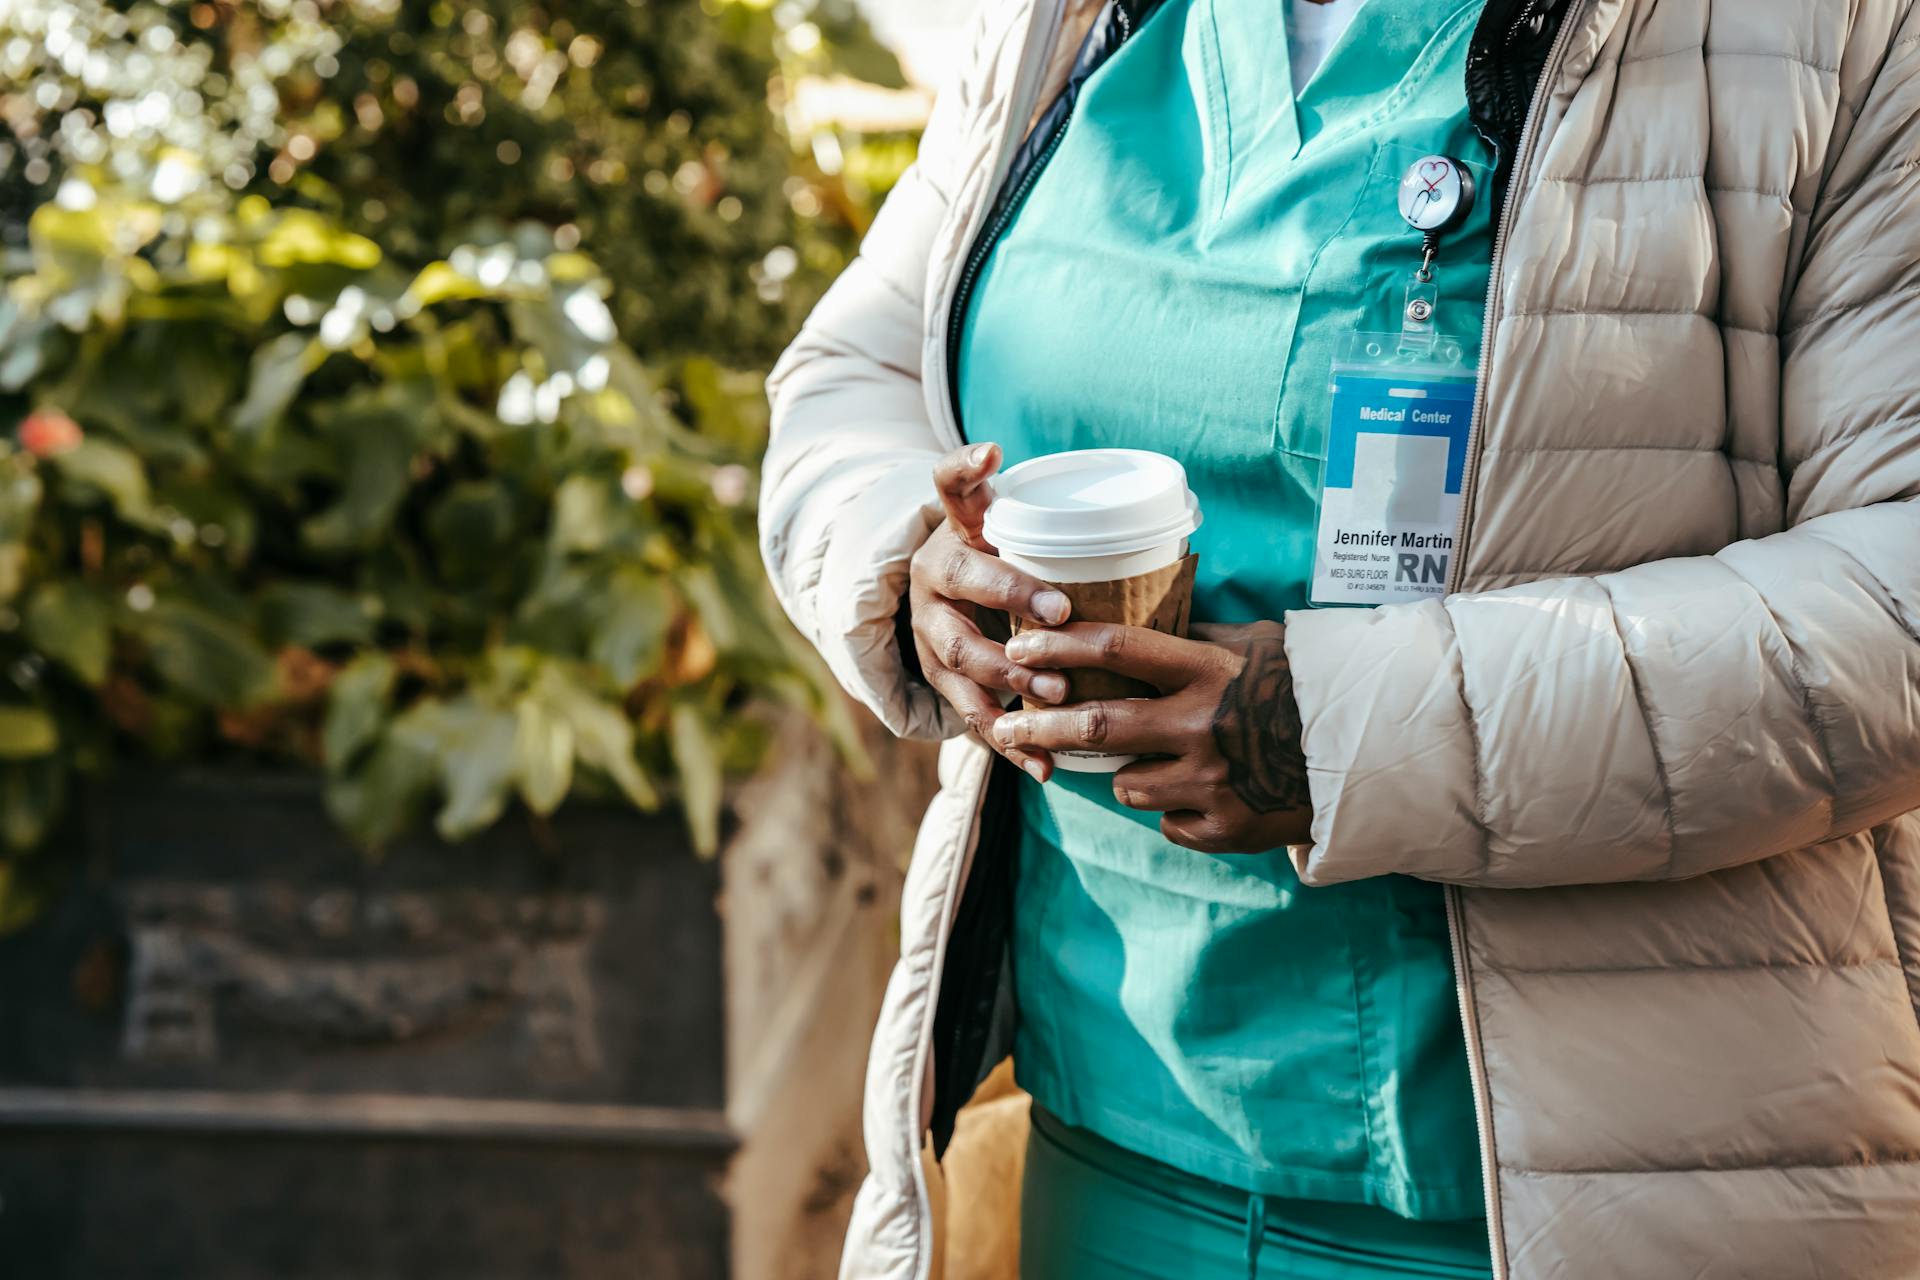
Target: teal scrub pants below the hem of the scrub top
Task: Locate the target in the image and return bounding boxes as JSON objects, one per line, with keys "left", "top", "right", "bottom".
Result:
{"left": 1020, "top": 1105, "right": 1492, "bottom": 1280}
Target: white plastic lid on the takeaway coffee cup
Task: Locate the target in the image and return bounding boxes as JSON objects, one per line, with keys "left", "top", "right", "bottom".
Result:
{"left": 983, "top": 449, "right": 1200, "bottom": 557}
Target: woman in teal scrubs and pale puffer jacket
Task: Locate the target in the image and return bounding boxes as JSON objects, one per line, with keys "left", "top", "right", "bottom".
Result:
{"left": 762, "top": 0, "right": 1920, "bottom": 1280}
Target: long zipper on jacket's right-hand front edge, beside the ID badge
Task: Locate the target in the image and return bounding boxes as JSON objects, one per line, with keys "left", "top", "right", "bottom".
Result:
{"left": 1446, "top": 0, "right": 1586, "bottom": 1280}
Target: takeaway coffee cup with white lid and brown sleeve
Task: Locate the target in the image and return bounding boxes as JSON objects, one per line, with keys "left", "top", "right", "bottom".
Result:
{"left": 983, "top": 449, "right": 1200, "bottom": 773}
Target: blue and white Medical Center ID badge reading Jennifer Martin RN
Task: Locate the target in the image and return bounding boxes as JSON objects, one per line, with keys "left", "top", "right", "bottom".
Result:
{"left": 1308, "top": 332, "right": 1476, "bottom": 604}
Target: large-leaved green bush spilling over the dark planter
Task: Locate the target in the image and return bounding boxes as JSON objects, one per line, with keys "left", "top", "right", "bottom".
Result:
{"left": 0, "top": 189, "right": 856, "bottom": 898}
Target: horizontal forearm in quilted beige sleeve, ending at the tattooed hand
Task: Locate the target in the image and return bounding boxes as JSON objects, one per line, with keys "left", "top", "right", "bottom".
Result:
{"left": 1286, "top": 503, "right": 1920, "bottom": 887}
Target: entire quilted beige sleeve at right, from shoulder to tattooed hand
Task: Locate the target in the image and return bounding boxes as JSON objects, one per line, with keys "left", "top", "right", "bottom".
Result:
{"left": 1286, "top": 19, "right": 1920, "bottom": 887}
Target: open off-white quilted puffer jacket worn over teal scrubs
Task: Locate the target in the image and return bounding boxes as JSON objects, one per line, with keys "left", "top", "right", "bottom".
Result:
{"left": 762, "top": 0, "right": 1920, "bottom": 1280}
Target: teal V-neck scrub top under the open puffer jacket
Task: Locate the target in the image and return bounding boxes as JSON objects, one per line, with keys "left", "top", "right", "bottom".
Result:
{"left": 956, "top": 0, "right": 1492, "bottom": 1219}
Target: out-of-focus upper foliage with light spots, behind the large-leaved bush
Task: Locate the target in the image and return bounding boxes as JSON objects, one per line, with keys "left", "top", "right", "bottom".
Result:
{"left": 0, "top": 0, "right": 912, "bottom": 368}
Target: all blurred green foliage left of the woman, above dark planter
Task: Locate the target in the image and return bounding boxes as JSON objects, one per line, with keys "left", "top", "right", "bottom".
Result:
{"left": 0, "top": 0, "right": 929, "bottom": 925}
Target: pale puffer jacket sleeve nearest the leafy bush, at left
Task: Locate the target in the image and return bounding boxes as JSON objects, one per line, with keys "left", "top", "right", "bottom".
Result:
{"left": 760, "top": 4, "right": 1004, "bottom": 737}
